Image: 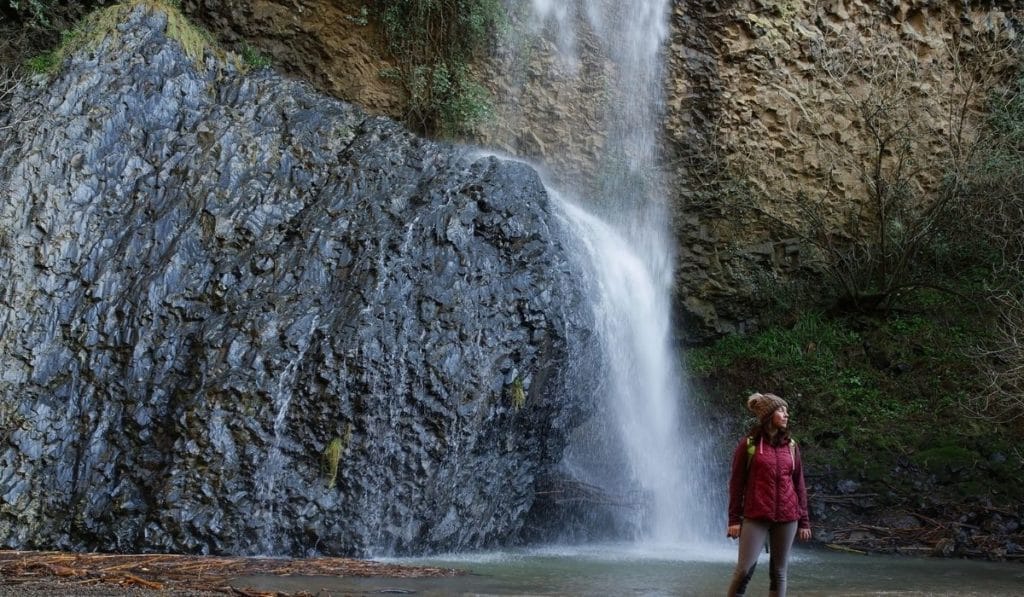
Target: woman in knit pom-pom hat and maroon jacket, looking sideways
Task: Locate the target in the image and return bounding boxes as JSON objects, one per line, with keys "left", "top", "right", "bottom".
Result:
{"left": 726, "top": 393, "right": 811, "bottom": 597}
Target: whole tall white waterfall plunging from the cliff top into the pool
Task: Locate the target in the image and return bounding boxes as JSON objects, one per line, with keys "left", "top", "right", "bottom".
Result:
{"left": 491, "top": 0, "right": 724, "bottom": 545}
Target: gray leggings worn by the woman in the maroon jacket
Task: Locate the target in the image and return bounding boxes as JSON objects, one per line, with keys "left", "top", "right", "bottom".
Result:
{"left": 728, "top": 520, "right": 797, "bottom": 597}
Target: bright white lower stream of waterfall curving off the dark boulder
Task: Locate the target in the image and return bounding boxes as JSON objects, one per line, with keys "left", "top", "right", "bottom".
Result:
{"left": 562, "top": 196, "right": 689, "bottom": 543}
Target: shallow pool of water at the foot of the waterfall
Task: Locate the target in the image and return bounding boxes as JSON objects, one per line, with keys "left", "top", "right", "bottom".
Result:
{"left": 232, "top": 544, "right": 1024, "bottom": 597}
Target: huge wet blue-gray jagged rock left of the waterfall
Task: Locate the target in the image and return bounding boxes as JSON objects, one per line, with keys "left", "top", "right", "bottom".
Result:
{"left": 0, "top": 4, "right": 593, "bottom": 555}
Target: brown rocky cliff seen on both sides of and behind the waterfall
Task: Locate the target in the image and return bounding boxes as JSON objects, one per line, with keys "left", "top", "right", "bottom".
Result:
{"left": 190, "top": 0, "right": 1024, "bottom": 343}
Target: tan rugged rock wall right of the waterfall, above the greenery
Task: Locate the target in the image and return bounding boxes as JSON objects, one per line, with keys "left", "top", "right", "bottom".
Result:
{"left": 666, "top": 0, "right": 1022, "bottom": 341}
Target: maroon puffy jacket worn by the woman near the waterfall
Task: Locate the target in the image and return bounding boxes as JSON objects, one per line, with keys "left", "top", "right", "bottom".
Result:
{"left": 729, "top": 437, "right": 811, "bottom": 528}
